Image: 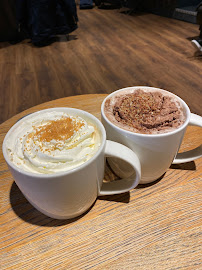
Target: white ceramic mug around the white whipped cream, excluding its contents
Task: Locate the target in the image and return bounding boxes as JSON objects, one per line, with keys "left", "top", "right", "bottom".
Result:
{"left": 3, "top": 108, "right": 141, "bottom": 219}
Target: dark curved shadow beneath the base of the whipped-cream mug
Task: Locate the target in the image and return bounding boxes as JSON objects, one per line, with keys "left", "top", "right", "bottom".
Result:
{"left": 10, "top": 182, "right": 95, "bottom": 227}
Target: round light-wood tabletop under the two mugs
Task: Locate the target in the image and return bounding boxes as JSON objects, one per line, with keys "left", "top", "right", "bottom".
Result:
{"left": 0, "top": 95, "right": 202, "bottom": 270}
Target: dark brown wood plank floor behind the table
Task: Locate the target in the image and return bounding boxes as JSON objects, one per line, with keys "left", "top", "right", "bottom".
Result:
{"left": 0, "top": 8, "right": 202, "bottom": 123}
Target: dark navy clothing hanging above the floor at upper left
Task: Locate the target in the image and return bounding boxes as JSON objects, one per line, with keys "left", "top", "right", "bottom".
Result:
{"left": 16, "top": 0, "right": 78, "bottom": 45}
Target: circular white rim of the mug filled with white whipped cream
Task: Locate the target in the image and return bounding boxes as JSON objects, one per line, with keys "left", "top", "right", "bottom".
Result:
{"left": 2, "top": 107, "right": 106, "bottom": 179}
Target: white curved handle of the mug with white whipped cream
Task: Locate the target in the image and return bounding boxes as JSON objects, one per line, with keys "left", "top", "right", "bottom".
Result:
{"left": 98, "top": 140, "right": 141, "bottom": 196}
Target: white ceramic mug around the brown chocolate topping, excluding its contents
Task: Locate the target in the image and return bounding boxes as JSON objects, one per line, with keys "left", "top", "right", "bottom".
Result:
{"left": 101, "top": 86, "right": 202, "bottom": 184}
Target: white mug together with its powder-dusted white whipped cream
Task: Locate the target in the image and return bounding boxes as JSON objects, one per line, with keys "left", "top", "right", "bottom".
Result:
{"left": 3, "top": 108, "right": 141, "bottom": 219}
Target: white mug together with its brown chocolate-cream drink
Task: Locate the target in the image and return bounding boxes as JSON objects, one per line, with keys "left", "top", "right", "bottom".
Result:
{"left": 101, "top": 86, "right": 202, "bottom": 184}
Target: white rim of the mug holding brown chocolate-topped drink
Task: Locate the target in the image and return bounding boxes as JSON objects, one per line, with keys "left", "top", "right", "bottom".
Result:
{"left": 101, "top": 86, "right": 191, "bottom": 138}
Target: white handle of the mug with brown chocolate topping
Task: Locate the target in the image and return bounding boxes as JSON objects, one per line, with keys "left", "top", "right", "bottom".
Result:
{"left": 172, "top": 113, "right": 202, "bottom": 164}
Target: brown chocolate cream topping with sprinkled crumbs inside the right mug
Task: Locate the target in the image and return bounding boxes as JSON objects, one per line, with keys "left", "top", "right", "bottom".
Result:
{"left": 104, "top": 88, "right": 186, "bottom": 134}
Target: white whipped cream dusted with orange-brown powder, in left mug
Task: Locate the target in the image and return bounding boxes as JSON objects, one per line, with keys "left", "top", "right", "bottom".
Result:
{"left": 6, "top": 111, "right": 100, "bottom": 174}
